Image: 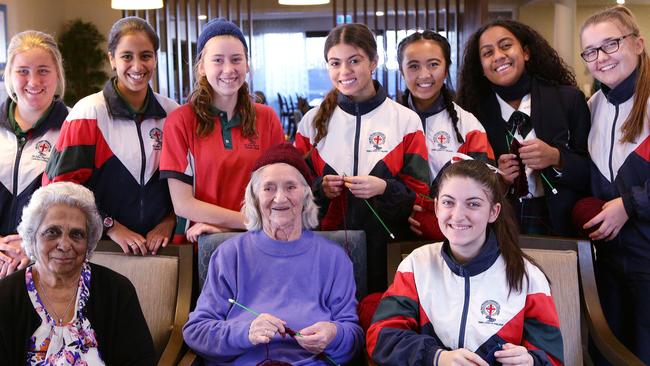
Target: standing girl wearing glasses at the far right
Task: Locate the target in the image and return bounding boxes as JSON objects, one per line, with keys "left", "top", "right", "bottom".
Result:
{"left": 580, "top": 6, "right": 650, "bottom": 363}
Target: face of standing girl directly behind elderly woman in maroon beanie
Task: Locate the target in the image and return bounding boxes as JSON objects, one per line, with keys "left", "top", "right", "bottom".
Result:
{"left": 327, "top": 43, "right": 377, "bottom": 102}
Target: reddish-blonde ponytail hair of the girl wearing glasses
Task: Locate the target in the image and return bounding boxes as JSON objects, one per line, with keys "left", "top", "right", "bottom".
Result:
{"left": 580, "top": 5, "right": 650, "bottom": 142}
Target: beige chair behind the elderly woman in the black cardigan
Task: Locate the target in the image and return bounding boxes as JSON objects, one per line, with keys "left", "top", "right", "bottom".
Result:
{"left": 91, "top": 241, "right": 193, "bottom": 366}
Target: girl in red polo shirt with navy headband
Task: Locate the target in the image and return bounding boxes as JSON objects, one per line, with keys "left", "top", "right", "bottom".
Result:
{"left": 160, "top": 18, "right": 284, "bottom": 242}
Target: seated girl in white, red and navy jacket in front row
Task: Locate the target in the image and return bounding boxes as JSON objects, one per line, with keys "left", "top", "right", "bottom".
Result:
{"left": 366, "top": 160, "right": 564, "bottom": 366}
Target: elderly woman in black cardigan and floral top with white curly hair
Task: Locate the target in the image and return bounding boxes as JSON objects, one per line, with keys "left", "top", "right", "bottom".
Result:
{"left": 0, "top": 182, "right": 155, "bottom": 365}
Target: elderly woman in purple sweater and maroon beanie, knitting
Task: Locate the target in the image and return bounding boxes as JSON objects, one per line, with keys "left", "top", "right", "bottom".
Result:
{"left": 183, "top": 143, "right": 363, "bottom": 365}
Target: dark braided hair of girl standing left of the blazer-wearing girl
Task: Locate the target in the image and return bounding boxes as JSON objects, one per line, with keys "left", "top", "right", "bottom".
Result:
{"left": 397, "top": 30, "right": 465, "bottom": 144}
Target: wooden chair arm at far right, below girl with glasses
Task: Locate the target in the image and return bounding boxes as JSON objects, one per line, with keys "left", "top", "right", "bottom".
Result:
{"left": 578, "top": 241, "right": 644, "bottom": 366}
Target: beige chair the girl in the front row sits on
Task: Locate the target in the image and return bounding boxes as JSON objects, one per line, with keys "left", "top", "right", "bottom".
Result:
{"left": 388, "top": 236, "right": 643, "bottom": 366}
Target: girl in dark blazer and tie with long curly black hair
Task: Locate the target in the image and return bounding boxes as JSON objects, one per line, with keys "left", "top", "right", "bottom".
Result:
{"left": 458, "top": 20, "right": 590, "bottom": 235}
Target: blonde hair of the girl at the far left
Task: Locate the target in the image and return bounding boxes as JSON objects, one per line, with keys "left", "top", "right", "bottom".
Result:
{"left": 4, "top": 30, "right": 65, "bottom": 102}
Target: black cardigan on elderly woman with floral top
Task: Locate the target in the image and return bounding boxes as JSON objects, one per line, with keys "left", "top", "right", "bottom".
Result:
{"left": 0, "top": 263, "right": 155, "bottom": 365}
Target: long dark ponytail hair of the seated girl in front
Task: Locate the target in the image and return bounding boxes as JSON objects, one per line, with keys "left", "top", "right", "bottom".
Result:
{"left": 436, "top": 160, "right": 539, "bottom": 292}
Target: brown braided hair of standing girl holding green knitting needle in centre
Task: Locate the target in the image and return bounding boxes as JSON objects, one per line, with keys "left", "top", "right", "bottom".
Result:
{"left": 312, "top": 23, "right": 377, "bottom": 144}
